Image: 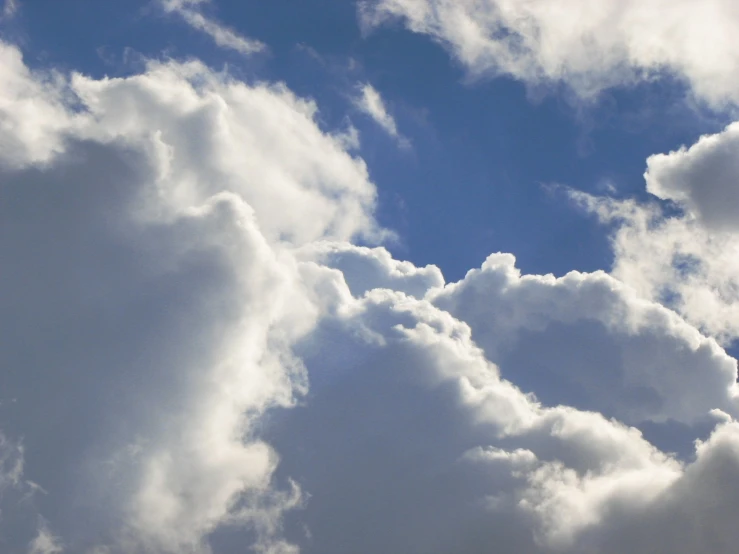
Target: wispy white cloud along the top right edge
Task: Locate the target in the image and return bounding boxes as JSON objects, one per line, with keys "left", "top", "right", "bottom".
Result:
{"left": 359, "top": 0, "right": 739, "bottom": 107}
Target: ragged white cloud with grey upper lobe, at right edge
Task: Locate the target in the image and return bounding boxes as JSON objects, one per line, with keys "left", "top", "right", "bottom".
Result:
{"left": 608, "top": 123, "right": 739, "bottom": 344}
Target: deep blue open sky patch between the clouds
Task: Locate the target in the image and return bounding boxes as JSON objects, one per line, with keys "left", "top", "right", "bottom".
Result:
{"left": 8, "top": 0, "right": 730, "bottom": 280}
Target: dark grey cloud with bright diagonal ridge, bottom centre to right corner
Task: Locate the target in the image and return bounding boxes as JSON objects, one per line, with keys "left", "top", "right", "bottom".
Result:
{"left": 267, "top": 268, "right": 737, "bottom": 554}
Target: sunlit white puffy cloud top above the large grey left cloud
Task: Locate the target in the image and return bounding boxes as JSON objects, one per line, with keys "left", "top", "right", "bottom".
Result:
{"left": 71, "top": 58, "right": 378, "bottom": 243}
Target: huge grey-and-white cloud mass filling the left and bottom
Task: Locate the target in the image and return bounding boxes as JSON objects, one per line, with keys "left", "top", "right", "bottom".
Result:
{"left": 0, "top": 2, "right": 739, "bottom": 554}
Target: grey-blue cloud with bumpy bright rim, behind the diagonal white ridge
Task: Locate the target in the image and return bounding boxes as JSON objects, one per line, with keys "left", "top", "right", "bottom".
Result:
{"left": 432, "top": 254, "right": 739, "bottom": 423}
